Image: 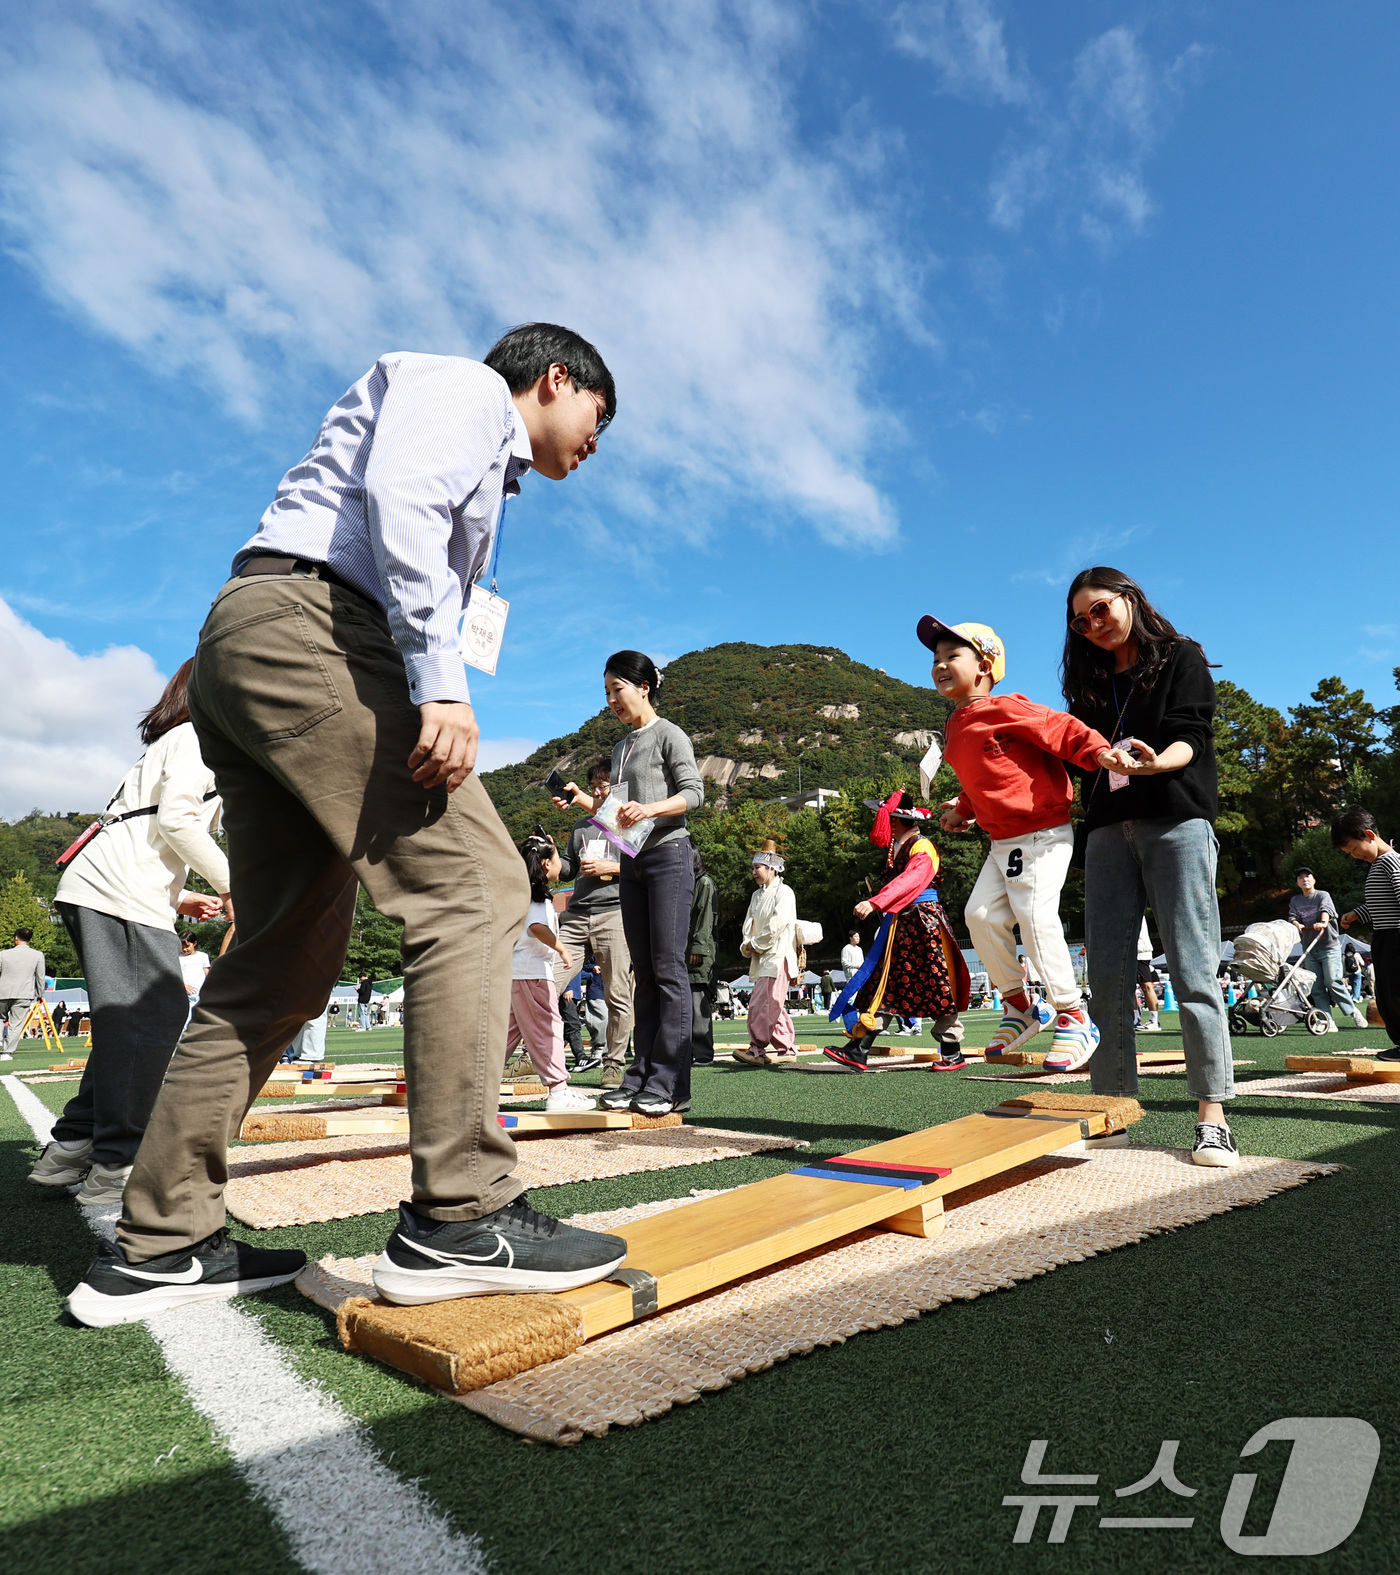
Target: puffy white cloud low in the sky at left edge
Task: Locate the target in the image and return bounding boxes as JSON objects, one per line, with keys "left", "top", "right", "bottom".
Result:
{"left": 0, "top": 602, "right": 165, "bottom": 821}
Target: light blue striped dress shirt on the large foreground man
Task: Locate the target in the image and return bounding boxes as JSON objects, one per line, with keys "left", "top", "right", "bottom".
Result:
{"left": 233, "top": 351, "right": 532, "bottom": 706}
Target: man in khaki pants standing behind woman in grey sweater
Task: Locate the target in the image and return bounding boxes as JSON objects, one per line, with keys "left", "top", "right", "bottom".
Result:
{"left": 554, "top": 761, "right": 631, "bottom": 1088}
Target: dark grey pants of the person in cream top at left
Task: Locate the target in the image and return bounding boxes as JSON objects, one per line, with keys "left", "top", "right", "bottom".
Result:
{"left": 54, "top": 902, "right": 189, "bottom": 1167}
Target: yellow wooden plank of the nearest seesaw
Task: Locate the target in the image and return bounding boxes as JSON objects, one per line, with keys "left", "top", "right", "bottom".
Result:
{"left": 561, "top": 1114, "right": 1104, "bottom": 1339}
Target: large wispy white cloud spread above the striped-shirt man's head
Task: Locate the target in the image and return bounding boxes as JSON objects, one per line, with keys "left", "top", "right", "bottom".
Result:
{"left": 0, "top": 0, "right": 919, "bottom": 543}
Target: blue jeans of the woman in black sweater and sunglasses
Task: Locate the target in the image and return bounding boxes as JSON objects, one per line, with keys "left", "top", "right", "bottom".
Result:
{"left": 1083, "top": 819, "right": 1235, "bottom": 1099}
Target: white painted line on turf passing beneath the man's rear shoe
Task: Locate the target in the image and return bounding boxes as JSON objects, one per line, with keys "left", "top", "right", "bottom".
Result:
{"left": 0, "top": 1076, "right": 488, "bottom": 1575}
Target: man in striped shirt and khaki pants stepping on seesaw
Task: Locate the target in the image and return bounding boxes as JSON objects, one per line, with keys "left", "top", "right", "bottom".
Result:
{"left": 71, "top": 323, "right": 627, "bottom": 1325}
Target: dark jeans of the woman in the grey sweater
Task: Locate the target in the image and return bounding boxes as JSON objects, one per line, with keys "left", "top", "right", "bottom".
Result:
{"left": 617, "top": 836, "right": 694, "bottom": 1104}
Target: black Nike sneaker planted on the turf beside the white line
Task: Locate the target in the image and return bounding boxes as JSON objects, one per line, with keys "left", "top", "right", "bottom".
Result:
{"left": 68, "top": 1230, "right": 306, "bottom": 1329}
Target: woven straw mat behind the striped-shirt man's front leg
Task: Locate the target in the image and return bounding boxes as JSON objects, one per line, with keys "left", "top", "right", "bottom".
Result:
{"left": 224, "top": 1126, "right": 806, "bottom": 1230}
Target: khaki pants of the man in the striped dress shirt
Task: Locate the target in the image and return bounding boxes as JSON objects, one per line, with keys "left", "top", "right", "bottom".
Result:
{"left": 118, "top": 575, "right": 529, "bottom": 1262}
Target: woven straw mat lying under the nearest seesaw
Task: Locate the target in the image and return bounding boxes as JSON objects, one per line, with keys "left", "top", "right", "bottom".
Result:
{"left": 305, "top": 1147, "right": 1342, "bottom": 1444}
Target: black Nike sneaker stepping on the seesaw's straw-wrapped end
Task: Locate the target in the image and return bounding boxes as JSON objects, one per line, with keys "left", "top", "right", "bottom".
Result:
{"left": 375, "top": 1195, "right": 627, "bottom": 1307}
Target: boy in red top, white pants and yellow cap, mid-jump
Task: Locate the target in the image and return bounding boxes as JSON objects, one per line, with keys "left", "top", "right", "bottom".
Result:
{"left": 918, "top": 617, "right": 1132, "bottom": 1071}
